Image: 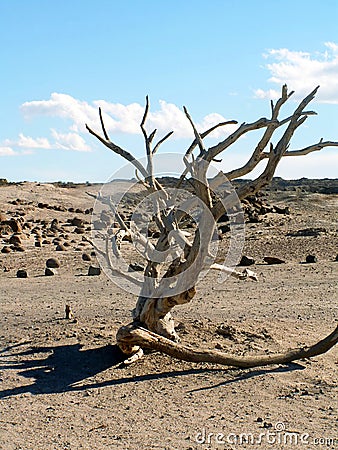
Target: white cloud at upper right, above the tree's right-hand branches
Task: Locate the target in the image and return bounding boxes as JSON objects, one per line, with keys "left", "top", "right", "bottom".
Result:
{"left": 255, "top": 42, "right": 338, "bottom": 104}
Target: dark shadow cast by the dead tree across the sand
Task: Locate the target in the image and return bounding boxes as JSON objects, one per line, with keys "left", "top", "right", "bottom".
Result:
{"left": 0, "top": 344, "right": 304, "bottom": 398}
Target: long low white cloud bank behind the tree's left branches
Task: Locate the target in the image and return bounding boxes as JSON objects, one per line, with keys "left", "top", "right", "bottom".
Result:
{"left": 0, "top": 92, "right": 236, "bottom": 156}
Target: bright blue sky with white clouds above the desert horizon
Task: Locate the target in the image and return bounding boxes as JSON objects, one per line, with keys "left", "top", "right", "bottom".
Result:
{"left": 0, "top": 0, "right": 338, "bottom": 182}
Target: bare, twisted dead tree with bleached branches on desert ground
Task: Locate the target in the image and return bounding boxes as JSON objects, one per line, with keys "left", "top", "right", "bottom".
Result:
{"left": 86, "top": 85, "right": 338, "bottom": 367}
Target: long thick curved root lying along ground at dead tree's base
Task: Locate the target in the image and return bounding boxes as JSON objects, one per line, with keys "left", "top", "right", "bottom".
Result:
{"left": 116, "top": 323, "right": 338, "bottom": 368}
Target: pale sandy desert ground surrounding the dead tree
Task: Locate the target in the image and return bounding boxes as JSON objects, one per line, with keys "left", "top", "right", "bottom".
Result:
{"left": 0, "top": 183, "right": 338, "bottom": 450}
